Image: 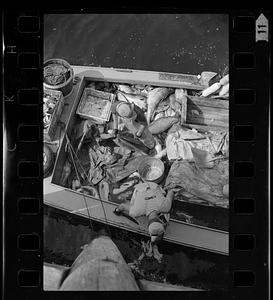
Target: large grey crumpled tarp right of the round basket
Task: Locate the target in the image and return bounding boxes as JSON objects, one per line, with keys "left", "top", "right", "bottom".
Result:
{"left": 165, "top": 160, "right": 229, "bottom": 207}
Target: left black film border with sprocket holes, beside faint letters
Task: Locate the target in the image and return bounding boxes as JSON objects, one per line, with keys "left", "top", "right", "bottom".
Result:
{"left": 2, "top": 12, "right": 43, "bottom": 292}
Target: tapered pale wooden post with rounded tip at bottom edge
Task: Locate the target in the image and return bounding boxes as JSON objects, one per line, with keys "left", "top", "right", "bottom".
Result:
{"left": 59, "top": 236, "right": 139, "bottom": 291}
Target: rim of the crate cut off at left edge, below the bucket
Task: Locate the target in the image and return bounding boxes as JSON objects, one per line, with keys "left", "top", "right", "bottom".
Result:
{"left": 44, "top": 88, "right": 64, "bottom": 141}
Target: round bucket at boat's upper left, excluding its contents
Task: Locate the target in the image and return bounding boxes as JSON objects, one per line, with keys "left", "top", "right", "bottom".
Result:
{"left": 44, "top": 58, "right": 74, "bottom": 97}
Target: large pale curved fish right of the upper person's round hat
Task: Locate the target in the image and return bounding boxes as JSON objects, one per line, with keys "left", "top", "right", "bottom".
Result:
{"left": 146, "top": 87, "right": 174, "bottom": 124}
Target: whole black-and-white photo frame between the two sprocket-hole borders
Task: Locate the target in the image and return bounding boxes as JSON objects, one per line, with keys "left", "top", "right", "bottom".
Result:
{"left": 42, "top": 13, "right": 230, "bottom": 292}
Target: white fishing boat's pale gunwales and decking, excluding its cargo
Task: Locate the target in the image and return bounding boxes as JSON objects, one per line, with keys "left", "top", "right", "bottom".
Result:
{"left": 43, "top": 66, "right": 229, "bottom": 255}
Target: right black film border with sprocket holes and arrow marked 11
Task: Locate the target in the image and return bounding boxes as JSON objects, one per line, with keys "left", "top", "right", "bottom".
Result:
{"left": 230, "top": 12, "right": 270, "bottom": 299}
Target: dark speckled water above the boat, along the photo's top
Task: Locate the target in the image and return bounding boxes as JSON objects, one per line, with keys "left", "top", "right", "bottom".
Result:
{"left": 44, "top": 14, "right": 228, "bottom": 74}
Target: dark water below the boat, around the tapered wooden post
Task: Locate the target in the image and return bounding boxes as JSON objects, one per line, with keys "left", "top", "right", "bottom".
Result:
{"left": 44, "top": 206, "right": 228, "bottom": 290}
